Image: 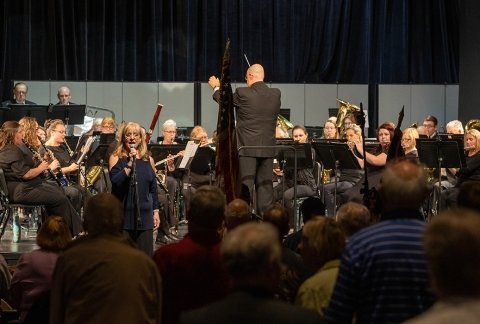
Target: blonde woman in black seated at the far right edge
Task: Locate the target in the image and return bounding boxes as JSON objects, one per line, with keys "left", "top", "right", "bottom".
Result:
{"left": 440, "top": 129, "right": 480, "bottom": 207}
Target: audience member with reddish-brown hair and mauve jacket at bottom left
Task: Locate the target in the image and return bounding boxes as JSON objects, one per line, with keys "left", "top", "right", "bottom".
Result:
{"left": 11, "top": 216, "right": 72, "bottom": 322}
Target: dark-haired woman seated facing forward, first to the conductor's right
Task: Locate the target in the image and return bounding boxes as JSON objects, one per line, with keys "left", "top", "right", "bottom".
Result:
{"left": 273, "top": 125, "right": 317, "bottom": 227}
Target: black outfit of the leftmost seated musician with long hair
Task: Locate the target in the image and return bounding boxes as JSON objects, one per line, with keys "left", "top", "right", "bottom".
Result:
{"left": 0, "top": 144, "right": 83, "bottom": 235}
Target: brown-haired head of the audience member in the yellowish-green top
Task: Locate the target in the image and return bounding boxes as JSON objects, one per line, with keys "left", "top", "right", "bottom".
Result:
{"left": 299, "top": 216, "right": 346, "bottom": 270}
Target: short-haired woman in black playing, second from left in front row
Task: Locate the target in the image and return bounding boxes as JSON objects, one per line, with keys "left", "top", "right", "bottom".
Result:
{"left": 40, "top": 119, "right": 86, "bottom": 211}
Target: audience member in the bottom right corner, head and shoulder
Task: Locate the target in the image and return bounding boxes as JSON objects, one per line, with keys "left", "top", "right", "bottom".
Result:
{"left": 407, "top": 210, "right": 480, "bottom": 324}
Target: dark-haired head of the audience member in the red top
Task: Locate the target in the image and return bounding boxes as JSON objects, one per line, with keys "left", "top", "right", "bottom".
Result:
{"left": 187, "top": 186, "right": 225, "bottom": 230}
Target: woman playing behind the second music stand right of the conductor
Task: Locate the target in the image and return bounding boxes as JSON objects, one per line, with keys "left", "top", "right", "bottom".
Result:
{"left": 323, "top": 124, "right": 363, "bottom": 217}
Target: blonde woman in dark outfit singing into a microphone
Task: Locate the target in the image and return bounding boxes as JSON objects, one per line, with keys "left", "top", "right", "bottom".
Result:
{"left": 108, "top": 122, "right": 160, "bottom": 255}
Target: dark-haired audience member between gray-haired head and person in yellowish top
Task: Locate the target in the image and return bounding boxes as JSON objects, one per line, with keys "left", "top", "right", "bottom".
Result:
{"left": 263, "top": 204, "right": 307, "bottom": 303}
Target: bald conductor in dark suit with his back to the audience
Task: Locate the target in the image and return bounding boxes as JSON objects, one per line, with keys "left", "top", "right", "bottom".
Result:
{"left": 208, "top": 64, "right": 281, "bottom": 213}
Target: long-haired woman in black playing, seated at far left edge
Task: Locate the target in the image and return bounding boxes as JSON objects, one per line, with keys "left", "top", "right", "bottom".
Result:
{"left": 0, "top": 121, "right": 83, "bottom": 235}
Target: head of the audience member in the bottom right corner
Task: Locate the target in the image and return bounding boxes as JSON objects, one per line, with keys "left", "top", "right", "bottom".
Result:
{"left": 423, "top": 209, "right": 480, "bottom": 299}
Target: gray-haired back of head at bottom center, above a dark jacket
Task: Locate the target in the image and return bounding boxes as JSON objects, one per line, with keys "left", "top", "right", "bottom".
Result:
{"left": 221, "top": 222, "right": 281, "bottom": 277}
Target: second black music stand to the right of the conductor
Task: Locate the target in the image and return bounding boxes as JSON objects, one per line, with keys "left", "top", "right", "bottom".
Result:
{"left": 312, "top": 141, "right": 361, "bottom": 208}
